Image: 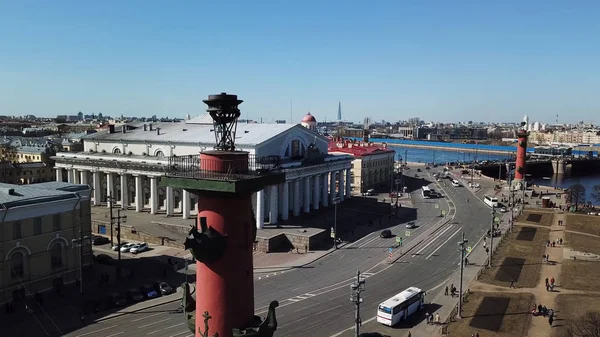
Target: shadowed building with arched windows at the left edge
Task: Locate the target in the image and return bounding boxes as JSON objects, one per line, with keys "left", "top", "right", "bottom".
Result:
{"left": 0, "top": 182, "right": 91, "bottom": 303}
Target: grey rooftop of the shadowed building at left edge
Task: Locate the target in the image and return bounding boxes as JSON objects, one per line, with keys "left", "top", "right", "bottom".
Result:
{"left": 0, "top": 181, "right": 89, "bottom": 208}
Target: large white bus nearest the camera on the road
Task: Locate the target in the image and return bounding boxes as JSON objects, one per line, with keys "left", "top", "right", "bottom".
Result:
{"left": 377, "top": 287, "right": 425, "bottom": 326}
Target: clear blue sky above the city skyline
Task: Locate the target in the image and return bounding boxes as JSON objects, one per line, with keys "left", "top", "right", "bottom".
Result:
{"left": 0, "top": 0, "right": 600, "bottom": 122}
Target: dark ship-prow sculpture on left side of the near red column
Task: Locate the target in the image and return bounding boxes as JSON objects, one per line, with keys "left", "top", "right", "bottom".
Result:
{"left": 183, "top": 217, "right": 228, "bottom": 264}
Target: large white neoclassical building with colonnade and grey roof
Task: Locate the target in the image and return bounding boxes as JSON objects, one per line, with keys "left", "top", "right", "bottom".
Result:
{"left": 54, "top": 114, "right": 352, "bottom": 228}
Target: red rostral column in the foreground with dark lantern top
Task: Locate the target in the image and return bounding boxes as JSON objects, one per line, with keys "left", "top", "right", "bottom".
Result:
{"left": 164, "top": 93, "right": 285, "bottom": 337}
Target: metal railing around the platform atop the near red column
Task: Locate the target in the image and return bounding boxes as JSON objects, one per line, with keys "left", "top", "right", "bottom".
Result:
{"left": 165, "top": 155, "right": 282, "bottom": 180}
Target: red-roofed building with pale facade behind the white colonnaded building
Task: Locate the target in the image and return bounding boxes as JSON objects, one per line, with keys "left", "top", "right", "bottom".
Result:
{"left": 328, "top": 137, "right": 396, "bottom": 193}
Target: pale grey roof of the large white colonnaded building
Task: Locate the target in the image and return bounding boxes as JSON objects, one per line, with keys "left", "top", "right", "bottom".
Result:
{"left": 83, "top": 121, "right": 301, "bottom": 147}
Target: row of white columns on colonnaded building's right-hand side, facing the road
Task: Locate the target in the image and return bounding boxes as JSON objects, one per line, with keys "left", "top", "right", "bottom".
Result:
{"left": 252, "top": 169, "right": 352, "bottom": 229}
